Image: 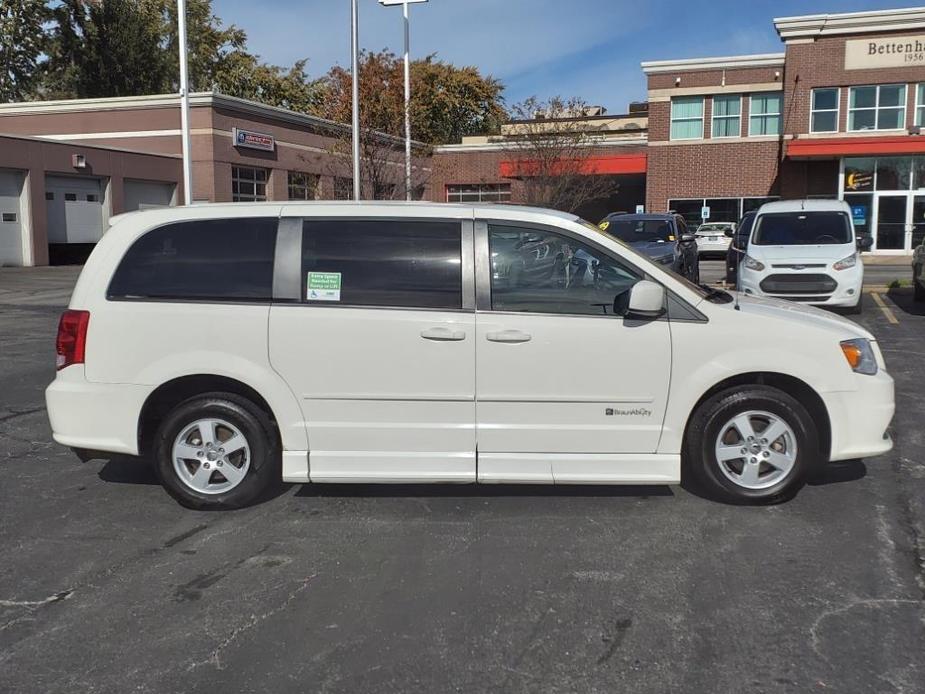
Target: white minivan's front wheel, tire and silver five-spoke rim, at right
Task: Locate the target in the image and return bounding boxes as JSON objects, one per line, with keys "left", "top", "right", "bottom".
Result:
{"left": 685, "top": 386, "right": 820, "bottom": 504}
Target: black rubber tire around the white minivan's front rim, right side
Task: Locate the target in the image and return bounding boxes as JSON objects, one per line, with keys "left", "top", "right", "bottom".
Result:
{"left": 684, "top": 386, "right": 822, "bottom": 505}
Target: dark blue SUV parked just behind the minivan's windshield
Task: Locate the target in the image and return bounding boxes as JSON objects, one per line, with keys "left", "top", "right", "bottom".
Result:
{"left": 598, "top": 213, "right": 700, "bottom": 284}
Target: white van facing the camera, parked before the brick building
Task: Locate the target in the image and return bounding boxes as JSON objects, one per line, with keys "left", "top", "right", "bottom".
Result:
{"left": 739, "top": 200, "right": 870, "bottom": 313}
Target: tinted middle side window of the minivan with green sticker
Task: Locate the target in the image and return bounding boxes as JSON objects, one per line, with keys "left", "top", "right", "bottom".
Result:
{"left": 302, "top": 219, "right": 462, "bottom": 309}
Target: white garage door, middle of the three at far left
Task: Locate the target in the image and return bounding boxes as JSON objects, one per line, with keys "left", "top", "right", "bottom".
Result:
{"left": 45, "top": 176, "right": 103, "bottom": 244}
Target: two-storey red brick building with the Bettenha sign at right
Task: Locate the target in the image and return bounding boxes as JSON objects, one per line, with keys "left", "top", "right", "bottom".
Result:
{"left": 642, "top": 9, "right": 925, "bottom": 253}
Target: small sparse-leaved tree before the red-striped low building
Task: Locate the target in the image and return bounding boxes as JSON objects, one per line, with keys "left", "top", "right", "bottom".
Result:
{"left": 505, "top": 97, "right": 618, "bottom": 212}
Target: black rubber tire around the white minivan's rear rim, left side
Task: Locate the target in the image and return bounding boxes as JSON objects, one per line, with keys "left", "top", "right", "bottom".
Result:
{"left": 154, "top": 393, "right": 282, "bottom": 510}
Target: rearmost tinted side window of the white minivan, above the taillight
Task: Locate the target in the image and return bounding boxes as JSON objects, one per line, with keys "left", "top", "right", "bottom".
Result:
{"left": 107, "top": 217, "right": 279, "bottom": 302}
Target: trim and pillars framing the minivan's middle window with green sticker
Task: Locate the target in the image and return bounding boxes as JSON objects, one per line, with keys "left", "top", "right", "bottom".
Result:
{"left": 273, "top": 215, "right": 476, "bottom": 313}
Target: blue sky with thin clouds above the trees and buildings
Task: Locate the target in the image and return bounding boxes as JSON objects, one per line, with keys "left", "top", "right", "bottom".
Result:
{"left": 213, "top": 0, "right": 911, "bottom": 113}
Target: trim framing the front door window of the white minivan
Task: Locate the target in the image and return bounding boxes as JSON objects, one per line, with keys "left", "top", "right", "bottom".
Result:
{"left": 475, "top": 217, "right": 709, "bottom": 323}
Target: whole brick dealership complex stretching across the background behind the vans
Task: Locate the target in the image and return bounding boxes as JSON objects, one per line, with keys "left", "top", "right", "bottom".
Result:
{"left": 0, "top": 8, "right": 925, "bottom": 265}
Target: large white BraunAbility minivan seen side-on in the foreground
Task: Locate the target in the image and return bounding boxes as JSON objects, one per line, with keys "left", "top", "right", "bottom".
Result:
{"left": 47, "top": 202, "right": 894, "bottom": 508}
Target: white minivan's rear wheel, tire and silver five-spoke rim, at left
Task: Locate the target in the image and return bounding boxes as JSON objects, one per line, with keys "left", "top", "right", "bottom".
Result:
{"left": 154, "top": 393, "right": 280, "bottom": 509}
